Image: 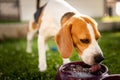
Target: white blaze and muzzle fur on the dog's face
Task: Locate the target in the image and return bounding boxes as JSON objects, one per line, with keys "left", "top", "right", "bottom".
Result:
{"left": 81, "top": 24, "right": 103, "bottom": 65}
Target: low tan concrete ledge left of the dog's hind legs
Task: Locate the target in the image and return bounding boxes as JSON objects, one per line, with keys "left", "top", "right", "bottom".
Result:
{"left": 0, "top": 23, "right": 28, "bottom": 39}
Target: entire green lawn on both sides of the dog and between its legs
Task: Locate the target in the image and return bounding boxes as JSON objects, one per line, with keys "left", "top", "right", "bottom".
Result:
{"left": 0, "top": 32, "right": 120, "bottom": 80}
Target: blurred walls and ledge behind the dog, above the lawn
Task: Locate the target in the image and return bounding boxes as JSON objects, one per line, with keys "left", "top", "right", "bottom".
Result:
{"left": 0, "top": 0, "right": 120, "bottom": 39}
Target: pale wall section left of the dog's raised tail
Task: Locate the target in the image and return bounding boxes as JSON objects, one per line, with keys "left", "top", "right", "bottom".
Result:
{"left": 20, "top": 0, "right": 36, "bottom": 21}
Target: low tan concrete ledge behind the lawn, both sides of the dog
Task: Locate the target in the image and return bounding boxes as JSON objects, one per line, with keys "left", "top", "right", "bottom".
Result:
{"left": 0, "top": 22, "right": 120, "bottom": 40}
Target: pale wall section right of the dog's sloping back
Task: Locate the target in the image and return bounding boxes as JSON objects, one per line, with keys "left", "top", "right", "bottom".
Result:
{"left": 66, "top": 0, "right": 104, "bottom": 17}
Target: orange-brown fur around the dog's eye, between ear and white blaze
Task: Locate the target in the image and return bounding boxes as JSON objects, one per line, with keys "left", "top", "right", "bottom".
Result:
{"left": 71, "top": 18, "right": 91, "bottom": 55}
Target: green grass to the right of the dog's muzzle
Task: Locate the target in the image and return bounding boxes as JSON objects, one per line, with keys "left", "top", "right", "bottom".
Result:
{"left": 99, "top": 32, "right": 120, "bottom": 74}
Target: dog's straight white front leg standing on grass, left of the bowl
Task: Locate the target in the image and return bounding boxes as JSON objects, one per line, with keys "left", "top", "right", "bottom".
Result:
{"left": 38, "top": 35, "right": 47, "bottom": 71}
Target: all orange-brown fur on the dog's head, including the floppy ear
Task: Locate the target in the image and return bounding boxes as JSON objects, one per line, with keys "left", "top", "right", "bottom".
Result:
{"left": 56, "top": 17, "right": 100, "bottom": 58}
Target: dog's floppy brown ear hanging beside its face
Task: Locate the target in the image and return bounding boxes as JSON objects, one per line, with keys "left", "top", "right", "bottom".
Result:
{"left": 55, "top": 24, "right": 73, "bottom": 58}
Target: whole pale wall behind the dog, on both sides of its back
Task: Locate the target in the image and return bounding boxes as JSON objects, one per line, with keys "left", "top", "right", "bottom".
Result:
{"left": 20, "top": 0, "right": 104, "bottom": 21}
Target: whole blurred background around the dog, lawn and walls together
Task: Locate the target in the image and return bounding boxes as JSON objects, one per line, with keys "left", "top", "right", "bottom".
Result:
{"left": 0, "top": 0, "right": 120, "bottom": 80}
